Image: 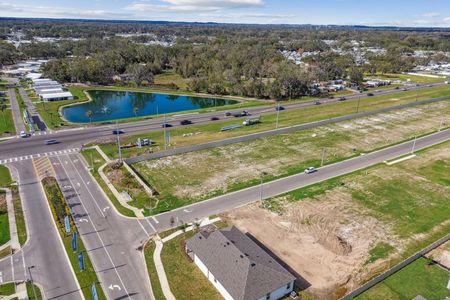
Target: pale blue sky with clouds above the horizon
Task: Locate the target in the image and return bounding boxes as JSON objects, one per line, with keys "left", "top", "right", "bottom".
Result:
{"left": 0, "top": 0, "right": 450, "bottom": 27}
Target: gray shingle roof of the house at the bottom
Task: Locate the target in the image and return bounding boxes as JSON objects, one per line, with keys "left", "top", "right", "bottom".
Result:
{"left": 186, "top": 226, "right": 295, "bottom": 300}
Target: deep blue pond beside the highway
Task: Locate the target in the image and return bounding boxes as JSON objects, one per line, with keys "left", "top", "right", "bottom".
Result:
{"left": 62, "top": 90, "right": 237, "bottom": 123}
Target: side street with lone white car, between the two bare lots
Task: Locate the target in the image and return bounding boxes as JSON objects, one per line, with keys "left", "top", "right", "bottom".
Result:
{"left": 151, "top": 129, "right": 450, "bottom": 232}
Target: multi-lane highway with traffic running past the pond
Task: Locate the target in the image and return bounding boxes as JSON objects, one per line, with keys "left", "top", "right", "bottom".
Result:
{"left": 0, "top": 84, "right": 442, "bottom": 160}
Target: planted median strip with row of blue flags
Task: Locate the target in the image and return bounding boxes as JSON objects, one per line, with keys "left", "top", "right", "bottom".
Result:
{"left": 42, "top": 177, "right": 106, "bottom": 299}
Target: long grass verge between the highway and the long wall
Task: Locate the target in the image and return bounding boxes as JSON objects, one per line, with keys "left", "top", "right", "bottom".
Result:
{"left": 101, "top": 86, "right": 450, "bottom": 158}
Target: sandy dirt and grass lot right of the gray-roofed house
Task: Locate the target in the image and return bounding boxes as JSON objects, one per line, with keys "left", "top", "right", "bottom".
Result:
{"left": 223, "top": 143, "right": 450, "bottom": 299}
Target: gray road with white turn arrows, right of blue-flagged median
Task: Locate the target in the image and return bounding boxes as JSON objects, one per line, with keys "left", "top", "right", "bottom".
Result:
{"left": 51, "top": 154, "right": 155, "bottom": 299}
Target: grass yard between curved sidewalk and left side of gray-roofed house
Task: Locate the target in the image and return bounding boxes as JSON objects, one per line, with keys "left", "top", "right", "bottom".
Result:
{"left": 161, "top": 231, "right": 222, "bottom": 300}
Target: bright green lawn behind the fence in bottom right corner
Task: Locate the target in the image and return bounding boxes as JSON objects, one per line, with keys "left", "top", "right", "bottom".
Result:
{"left": 355, "top": 258, "right": 450, "bottom": 300}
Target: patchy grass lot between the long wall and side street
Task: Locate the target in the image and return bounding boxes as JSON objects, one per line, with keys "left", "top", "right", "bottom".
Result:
{"left": 133, "top": 102, "right": 450, "bottom": 213}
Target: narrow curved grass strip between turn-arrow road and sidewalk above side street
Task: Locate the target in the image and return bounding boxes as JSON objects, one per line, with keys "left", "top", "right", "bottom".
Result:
{"left": 81, "top": 149, "right": 135, "bottom": 217}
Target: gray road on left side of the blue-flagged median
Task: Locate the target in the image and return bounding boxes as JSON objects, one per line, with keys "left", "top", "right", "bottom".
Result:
{"left": 0, "top": 161, "right": 82, "bottom": 300}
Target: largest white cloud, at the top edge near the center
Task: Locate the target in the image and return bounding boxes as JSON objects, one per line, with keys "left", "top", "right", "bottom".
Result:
{"left": 126, "top": 0, "right": 264, "bottom": 12}
